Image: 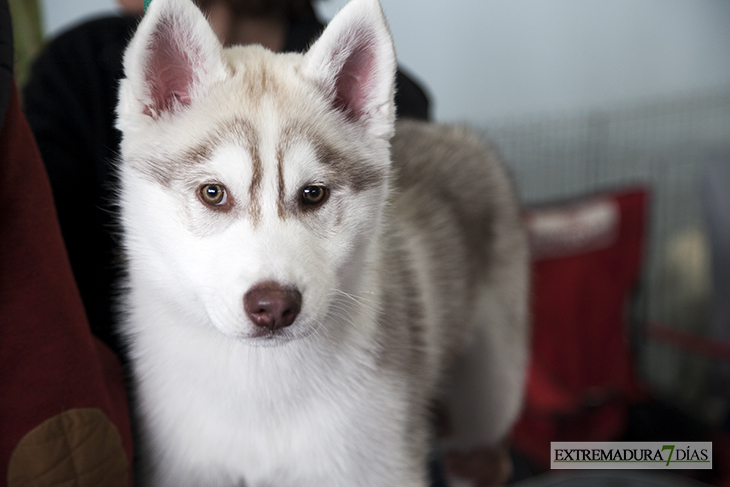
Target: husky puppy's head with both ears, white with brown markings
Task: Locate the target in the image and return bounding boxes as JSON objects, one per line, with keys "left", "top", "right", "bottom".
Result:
{"left": 118, "top": 0, "right": 395, "bottom": 345}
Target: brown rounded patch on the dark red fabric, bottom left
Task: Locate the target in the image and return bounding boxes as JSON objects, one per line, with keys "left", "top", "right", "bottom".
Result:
{"left": 8, "top": 408, "right": 129, "bottom": 487}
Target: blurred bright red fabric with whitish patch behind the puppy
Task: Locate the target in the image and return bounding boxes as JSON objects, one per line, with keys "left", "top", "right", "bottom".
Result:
{"left": 513, "top": 188, "right": 648, "bottom": 467}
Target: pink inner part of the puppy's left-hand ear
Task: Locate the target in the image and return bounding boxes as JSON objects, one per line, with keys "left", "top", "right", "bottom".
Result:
{"left": 145, "top": 19, "right": 200, "bottom": 114}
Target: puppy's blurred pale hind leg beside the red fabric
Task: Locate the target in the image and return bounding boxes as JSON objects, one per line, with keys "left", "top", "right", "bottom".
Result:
{"left": 438, "top": 255, "right": 529, "bottom": 487}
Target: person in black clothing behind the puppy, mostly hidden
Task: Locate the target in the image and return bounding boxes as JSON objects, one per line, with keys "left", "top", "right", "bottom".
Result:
{"left": 23, "top": 0, "right": 429, "bottom": 360}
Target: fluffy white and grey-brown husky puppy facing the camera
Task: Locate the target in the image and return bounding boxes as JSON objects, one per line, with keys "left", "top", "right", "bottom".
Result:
{"left": 118, "top": 0, "right": 527, "bottom": 487}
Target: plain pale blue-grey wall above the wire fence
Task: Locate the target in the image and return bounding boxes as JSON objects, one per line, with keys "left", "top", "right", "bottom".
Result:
{"left": 42, "top": 0, "right": 730, "bottom": 123}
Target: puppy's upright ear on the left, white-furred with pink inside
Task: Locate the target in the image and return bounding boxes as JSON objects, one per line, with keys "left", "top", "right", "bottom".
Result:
{"left": 120, "top": 0, "right": 225, "bottom": 119}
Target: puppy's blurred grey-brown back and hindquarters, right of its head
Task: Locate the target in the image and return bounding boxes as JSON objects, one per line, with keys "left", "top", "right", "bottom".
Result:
{"left": 384, "top": 121, "right": 528, "bottom": 452}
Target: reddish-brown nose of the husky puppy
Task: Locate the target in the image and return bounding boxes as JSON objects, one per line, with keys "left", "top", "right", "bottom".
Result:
{"left": 243, "top": 282, "right": 302, "bottom": 331}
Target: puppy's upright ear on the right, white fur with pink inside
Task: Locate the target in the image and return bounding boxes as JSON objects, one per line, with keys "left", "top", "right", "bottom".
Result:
{"left": 304, "top": 0, "right": 396, "bottom": 138}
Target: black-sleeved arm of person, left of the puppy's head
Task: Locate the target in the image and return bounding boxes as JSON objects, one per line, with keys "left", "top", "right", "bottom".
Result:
{"left": 23, "top": 17, "right": 136, "bottom": 358}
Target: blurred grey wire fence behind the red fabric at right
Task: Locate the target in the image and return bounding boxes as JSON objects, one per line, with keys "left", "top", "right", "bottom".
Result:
{"left": 480, "top": 86, "right": 730, "bottom": 422}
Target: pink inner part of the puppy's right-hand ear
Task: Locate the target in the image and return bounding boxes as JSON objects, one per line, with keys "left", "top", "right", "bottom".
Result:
{"left": 334, "top": 33, "right": 376, "bottom": 120}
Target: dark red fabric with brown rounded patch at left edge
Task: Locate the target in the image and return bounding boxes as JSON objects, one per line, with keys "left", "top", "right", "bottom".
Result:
{"left": 0, "top": 87, "right": 132, "bottom": 486}
